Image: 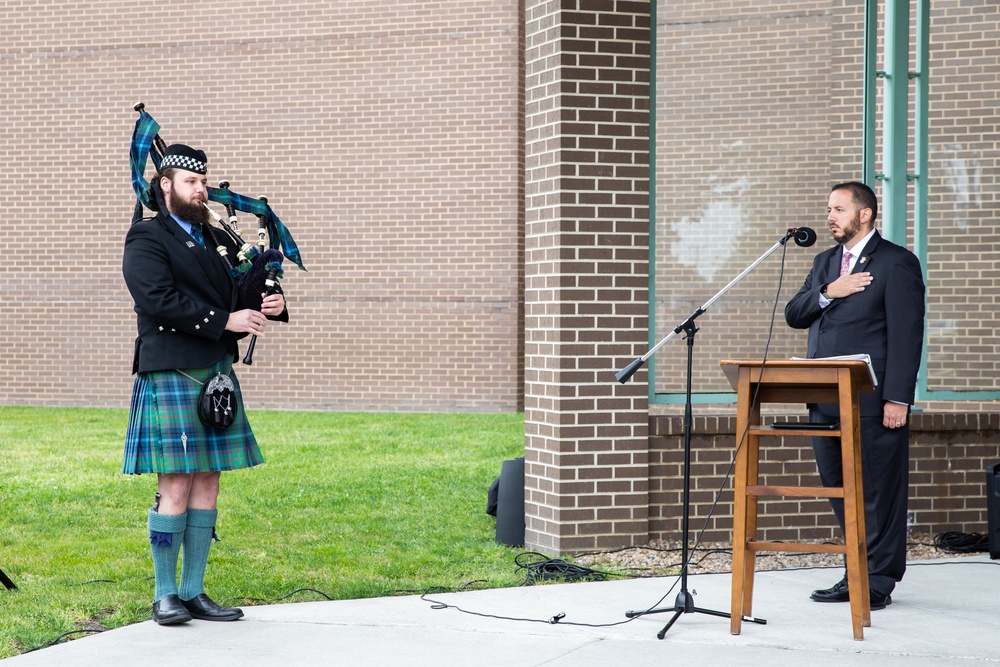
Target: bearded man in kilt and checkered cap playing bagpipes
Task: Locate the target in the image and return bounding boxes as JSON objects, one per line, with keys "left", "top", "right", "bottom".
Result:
{"left": 122, "top": 144, "right": 288, "bottom": 625}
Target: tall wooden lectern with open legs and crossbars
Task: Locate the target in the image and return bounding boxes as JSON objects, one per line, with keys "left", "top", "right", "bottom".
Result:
{"left": 721, "top": 359, "right": 874, "bottom": 640}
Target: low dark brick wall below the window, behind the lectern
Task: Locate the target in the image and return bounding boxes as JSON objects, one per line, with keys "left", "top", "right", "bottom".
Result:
{"left": 649, "top": 413, "right": 1000, "bottom": 542}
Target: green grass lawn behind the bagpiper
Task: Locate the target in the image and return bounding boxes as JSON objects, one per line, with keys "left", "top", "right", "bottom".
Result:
{"left": 0, "top": 407, "right": 524, "bottom": 659}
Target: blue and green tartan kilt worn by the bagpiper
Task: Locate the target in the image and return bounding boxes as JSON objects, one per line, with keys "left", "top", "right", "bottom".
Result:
{"left": 122, "top": 356, "right": 264, "bottom": 475}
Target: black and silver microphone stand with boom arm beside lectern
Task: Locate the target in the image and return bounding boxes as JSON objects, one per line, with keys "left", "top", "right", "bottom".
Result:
{"left": 615, "top": 228, "right": 816, "bottom": 639}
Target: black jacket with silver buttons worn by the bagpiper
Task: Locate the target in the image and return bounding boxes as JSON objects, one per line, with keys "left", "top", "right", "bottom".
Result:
{"left": 122, "top": 211, "right": 288, "bottom": 373}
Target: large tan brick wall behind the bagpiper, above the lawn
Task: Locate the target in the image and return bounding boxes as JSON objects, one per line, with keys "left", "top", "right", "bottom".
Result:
{"left": 0, "top": 0, "right": 523, "bottom": 412}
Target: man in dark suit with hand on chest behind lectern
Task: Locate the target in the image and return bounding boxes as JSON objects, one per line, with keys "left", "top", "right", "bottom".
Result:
{"left": 785, "top": 182, "right": 924, "bottom": 609}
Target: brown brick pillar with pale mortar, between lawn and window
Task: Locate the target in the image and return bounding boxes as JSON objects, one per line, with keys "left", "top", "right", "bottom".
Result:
{"left": 525, "top": 0, "right": 649, "bottom": 553}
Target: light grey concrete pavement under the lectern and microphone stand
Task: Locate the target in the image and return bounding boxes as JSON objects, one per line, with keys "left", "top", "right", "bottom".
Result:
{"left": 3, "top": 555, "right": 1000, "bottom": 667}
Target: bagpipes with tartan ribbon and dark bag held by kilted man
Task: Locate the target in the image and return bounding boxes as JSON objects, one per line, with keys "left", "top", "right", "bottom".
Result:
{"left": 129, "top": 102, "right": 306, "bottom": 364}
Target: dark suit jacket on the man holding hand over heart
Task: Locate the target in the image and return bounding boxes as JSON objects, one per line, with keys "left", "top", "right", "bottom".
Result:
{"left": 785, "top": 232, "right": 924, "bottom": 417}
